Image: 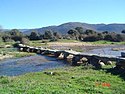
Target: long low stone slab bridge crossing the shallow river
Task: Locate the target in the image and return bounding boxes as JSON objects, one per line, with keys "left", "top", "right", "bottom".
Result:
{"left": 18, "top": 44, "right": 125, "bottom": 68}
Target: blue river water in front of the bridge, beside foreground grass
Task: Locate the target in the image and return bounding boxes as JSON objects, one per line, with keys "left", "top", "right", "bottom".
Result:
{"left": 0, "top": 55, "right": 67, "bottom": 76}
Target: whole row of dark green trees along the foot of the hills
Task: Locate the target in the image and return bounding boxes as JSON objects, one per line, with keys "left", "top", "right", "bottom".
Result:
{"left": 0, "top": 27, "right": 125, "bottom": 43}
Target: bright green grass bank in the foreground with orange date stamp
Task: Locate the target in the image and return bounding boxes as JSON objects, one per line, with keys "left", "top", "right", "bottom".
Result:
{"left": 0, "top": 67, "right": 125, "bottom": 94}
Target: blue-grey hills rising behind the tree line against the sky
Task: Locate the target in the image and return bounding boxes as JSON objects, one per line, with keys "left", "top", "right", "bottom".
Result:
{"left": 19, "top": 22, "right": 125, "bottom": 34}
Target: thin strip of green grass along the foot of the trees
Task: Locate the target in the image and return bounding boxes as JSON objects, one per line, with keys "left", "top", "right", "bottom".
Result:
{"left": 0, "top": 39, "right": 125, "bottom": 47}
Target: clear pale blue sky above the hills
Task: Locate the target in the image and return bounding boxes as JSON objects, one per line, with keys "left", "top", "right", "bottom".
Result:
{"left": 0, "top": 0, "right": 125, "bottom": 29}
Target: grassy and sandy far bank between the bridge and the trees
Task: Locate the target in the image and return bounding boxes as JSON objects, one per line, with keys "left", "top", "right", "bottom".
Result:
{"left": 0, "top": 39, "right": 125, "bottom": 54}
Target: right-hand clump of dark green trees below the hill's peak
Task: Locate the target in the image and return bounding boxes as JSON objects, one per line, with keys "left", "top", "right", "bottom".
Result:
{"left": 68, "top": 27, "right": 125, "bottom": 42}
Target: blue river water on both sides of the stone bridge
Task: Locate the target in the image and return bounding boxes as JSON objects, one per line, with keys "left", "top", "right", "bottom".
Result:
{"left": 0, "top": 45, "right": 125, "bottom": 76}
